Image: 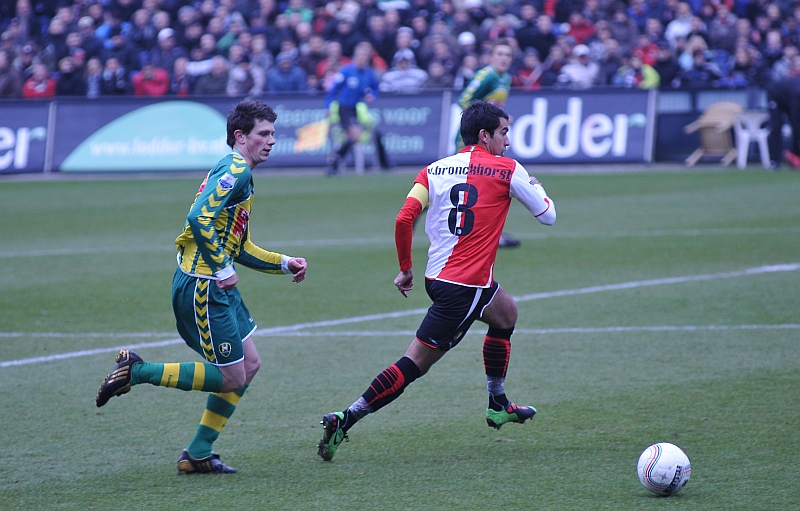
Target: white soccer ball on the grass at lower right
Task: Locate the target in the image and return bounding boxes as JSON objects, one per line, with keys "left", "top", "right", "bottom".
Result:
{"left": 637, "top": 442, "right": 692, "bottom": 497}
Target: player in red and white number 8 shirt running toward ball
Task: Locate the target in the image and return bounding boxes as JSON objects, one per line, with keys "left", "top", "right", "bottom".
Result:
{"left": 317, "top": 102, "right": 556, "bottom": 461}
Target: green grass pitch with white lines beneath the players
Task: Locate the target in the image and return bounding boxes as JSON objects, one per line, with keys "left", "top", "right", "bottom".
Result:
{"left": 0, "top": 166, "right": 800, "bottom": 511}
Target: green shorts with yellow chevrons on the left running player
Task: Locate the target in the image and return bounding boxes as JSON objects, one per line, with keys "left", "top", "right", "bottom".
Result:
{"left": 172, "top": 268, "right": 256, "bottom": 366}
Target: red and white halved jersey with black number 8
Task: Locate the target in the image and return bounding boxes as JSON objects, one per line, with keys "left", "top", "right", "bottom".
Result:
{"left": 395, "top": 145, "right": 556, "bottom": 287}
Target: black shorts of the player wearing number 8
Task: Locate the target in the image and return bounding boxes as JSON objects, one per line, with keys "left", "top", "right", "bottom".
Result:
{"left": 417, "top": 279, "right": 500, "bottom": 351}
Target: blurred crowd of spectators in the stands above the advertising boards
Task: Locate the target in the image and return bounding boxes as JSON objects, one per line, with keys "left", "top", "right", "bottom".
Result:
{"left": 0, "top": 0, "right": 800, "bottom": 98}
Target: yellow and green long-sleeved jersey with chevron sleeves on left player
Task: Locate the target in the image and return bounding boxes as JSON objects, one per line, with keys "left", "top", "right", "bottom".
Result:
{"left": 175, "top": 151, "right": 288, "bottom": 278}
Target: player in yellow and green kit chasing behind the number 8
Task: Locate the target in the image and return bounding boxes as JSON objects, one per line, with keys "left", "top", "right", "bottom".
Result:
{"left": 96, "top": 100, "right": 307, "bottom": 474}
